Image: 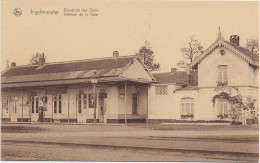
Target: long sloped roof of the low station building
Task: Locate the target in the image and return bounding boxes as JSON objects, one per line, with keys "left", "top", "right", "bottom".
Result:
{"left": 1, "top": 56, "right": 146, "bottom": 87}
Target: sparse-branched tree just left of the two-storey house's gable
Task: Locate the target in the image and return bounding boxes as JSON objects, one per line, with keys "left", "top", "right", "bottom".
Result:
{"left": 180, "top": 36, "right": 203, "bottom": 64}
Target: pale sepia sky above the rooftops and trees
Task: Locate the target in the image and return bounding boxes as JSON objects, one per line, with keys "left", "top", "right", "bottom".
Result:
{"left": 1, "top": 0, "right": 259, "bottom": 72}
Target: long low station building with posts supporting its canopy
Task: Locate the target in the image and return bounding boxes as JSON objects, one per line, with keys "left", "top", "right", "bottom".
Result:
{"left": 1, "top": 52, "right": 154, "bottom": 123}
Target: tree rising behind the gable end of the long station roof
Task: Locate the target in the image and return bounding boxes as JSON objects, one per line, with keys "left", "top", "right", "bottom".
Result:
{"left": 136, "top": 41, "right": 160, "bottom": 71}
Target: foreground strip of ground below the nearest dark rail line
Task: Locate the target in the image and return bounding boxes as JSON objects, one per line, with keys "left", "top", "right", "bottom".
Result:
{"left": 2, "top": 143, "right": 258, "bottom": 162}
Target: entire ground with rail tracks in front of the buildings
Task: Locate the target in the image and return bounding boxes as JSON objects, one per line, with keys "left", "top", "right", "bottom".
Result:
{"left": 1, "top": 124, "right": 259, "bottom": 162}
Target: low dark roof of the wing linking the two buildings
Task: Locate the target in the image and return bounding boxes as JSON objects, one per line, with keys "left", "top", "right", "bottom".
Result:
{"left": 153, "top": 71, "right": 198, "bottom": 84}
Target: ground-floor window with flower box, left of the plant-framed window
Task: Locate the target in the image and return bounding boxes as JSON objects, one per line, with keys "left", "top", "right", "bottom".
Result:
{"left": 181, "top": 98, "right": 194, "bottom": 115}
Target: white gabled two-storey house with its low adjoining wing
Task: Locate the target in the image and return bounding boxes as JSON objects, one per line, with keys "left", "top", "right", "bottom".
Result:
{"left": 148, "top": 34, "right": 259, "bottom": 122}
